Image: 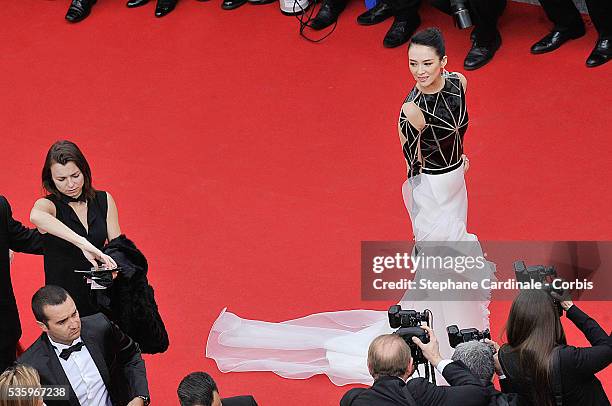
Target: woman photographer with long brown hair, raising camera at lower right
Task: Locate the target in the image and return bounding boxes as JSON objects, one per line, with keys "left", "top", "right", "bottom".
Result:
{"left": 498, "top": 290, "right": 612, "bottom": 406}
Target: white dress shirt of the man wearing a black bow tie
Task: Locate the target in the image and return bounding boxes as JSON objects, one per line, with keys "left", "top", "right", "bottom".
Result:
{"left": 49, "top": 337, "right": 112, "bottom": 406}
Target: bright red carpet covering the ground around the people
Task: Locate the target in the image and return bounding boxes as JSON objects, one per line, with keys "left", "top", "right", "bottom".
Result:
{"left": 0, "top": 0, "right": 612, "bottom": 405}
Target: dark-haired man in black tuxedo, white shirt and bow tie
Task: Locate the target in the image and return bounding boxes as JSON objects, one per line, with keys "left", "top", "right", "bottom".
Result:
{"left": 17, "top": 285, "right": 149, "bottom": 406}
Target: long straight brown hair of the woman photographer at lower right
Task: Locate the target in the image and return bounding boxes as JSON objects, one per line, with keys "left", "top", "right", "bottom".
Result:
{"left": 506, "top": 289, "right": 567, "bottom": 405}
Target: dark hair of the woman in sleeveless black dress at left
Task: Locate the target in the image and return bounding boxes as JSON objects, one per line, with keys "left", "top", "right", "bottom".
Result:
{"left": 42, "top": 140, "right": 96, "bottom": 199}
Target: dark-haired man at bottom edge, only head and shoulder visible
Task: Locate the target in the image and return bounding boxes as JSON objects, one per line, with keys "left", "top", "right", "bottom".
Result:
{"left": 176, "top": 372, "right": 257, "bottom": 406}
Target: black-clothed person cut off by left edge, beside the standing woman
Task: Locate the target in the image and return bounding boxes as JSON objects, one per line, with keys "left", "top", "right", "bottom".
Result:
{"left": 0, "top": 196, "right": 43, "bottom": 373}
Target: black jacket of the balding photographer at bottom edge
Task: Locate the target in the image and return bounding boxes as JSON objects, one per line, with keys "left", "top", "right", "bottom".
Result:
{"left": 340, "top": 361, "right": 490, "bottom": 406}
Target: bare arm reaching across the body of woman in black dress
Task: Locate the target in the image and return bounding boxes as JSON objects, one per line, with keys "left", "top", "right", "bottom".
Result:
{"left": 30, "top": 198, "right": 117, "bottom": 269}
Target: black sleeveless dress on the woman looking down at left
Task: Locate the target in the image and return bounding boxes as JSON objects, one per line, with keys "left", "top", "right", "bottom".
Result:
{"left": 43, "top": 191, "right": 108, "bottom": 316}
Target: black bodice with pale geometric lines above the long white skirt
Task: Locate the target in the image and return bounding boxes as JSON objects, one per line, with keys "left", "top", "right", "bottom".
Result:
{"left": 399, "top": 73, "right": 468, "bottom": 177}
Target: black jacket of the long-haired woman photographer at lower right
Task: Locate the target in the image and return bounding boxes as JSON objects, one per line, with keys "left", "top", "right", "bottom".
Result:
{"left": 499, "top": 305, "right": 612, "bottom": 406}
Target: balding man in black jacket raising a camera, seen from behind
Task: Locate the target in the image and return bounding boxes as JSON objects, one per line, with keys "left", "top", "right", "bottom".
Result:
{"left": 340, "top": 326, "right": 489, "bottom": 406}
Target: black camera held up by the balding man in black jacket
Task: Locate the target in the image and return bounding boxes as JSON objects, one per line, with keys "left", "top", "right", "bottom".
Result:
{"left": 388, "top": 305, "right": 429, "bottom": 365}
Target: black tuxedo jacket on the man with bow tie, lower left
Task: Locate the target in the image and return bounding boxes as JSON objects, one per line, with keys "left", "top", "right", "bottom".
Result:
{"left": 17, "top": 313, "right": 149, "bottom": 406}
